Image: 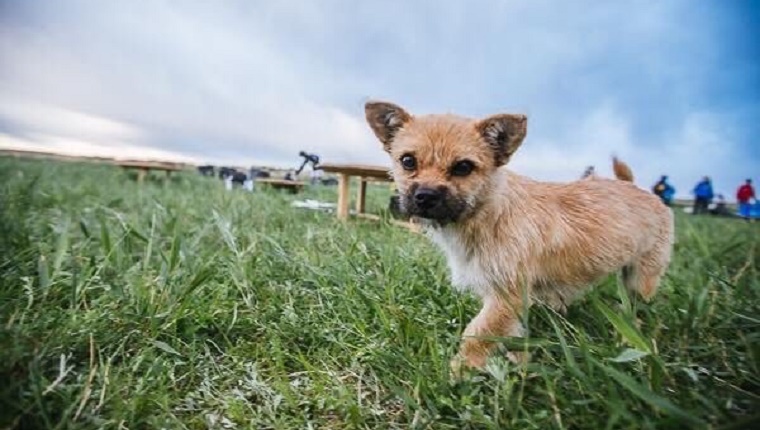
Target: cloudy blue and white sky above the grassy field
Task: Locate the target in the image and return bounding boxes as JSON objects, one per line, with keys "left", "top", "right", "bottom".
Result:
{"left": 0, "top": 0, "right": 760, "bottom": 199}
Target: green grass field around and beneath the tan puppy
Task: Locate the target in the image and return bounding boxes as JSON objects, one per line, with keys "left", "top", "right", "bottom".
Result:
{"left": 0, "top": 158, "right": 760, "bottom": 429}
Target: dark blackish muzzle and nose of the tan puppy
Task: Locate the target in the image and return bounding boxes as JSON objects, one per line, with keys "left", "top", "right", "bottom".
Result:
{"left": 400, "top": 185, "right": 468, "bottom": 225}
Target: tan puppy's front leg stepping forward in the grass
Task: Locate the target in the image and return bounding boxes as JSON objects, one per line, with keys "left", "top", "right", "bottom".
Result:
{"left": 451, "top": 295, "right": 523, "bottom": 374}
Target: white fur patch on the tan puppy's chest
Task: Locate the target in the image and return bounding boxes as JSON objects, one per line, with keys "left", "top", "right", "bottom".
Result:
{"left": 430, "top": 230, "right": 493, "bottom": 296}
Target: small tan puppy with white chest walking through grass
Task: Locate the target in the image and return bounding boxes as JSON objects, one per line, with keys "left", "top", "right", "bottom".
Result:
{"left": 365, "top": 102, "right": 673, "bottom": 373}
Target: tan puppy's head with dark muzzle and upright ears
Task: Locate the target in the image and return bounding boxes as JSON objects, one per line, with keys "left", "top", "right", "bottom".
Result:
{"left": 365, "top": 102, "right": 527, "bottom": 225}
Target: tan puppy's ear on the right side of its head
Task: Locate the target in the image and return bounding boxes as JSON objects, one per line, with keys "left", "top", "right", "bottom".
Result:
{"left": 475, "top": 114, "right": 528, "bottom": 166}
